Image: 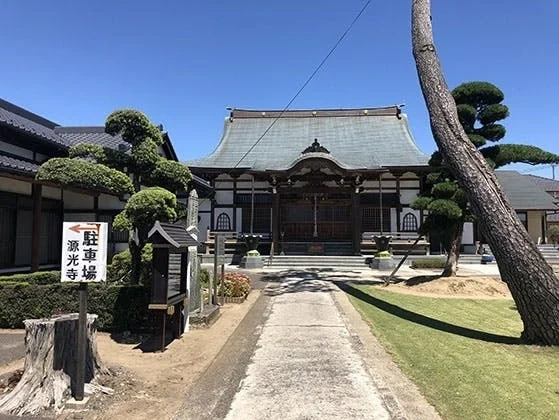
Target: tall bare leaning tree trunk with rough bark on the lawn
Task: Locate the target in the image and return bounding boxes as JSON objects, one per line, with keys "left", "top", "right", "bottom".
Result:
{"left": 412, "top": 0, "right": 559, "bottom": 345}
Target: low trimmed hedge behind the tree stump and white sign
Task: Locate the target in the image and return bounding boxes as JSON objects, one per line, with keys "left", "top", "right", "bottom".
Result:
{"left": 0, "top": 281, "right": 152, "bottom": 331}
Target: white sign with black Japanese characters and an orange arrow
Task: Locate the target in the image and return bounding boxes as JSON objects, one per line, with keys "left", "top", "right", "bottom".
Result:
{"left": 60, "top": 222, "right": 108, "bottom": 282}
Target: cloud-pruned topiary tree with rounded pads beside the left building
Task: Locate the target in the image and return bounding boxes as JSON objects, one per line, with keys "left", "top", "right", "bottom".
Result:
{"left": 37, "top": 109, "right": 192, "bottom": 284}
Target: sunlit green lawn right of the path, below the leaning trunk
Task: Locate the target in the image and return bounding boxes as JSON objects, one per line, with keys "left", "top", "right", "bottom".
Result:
{"left": 345, "top": 286, "right": 559, "bottom": 420}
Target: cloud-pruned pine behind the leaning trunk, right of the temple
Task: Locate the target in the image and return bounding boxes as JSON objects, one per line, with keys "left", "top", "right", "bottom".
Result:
{"left": 412, "top": 82, "right": 559, "bottom": 277}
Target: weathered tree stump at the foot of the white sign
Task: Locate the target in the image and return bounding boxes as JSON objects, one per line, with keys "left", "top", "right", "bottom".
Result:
{"left": 0, "top": 313, "right": 107, "bottom": 415}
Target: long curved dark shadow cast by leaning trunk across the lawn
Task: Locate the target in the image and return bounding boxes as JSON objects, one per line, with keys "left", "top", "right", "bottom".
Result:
{"left": 334, "top": 282, "right": 522, "bottom": 344}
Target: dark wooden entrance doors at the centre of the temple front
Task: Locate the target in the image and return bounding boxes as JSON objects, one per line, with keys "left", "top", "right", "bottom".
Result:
{"left": 280, "top": 193, "right": 351, "bottom": 242}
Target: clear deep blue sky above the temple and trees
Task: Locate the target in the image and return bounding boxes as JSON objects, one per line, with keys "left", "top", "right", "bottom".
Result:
{"left": 0, "top": 0, "right": 559, "bottom": 176}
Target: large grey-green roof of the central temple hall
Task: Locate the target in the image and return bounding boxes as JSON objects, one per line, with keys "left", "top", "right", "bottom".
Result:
{"left": 186, "top": 107, "right": 429, "bottom": 170}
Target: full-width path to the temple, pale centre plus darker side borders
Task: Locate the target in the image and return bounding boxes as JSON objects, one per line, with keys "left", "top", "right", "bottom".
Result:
{"left": 175, "top": 270, "right": 439, "bottom": 420}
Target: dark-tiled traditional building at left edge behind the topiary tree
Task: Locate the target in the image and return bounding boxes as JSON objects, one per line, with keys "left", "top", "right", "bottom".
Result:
{"left": 0, "top": 99, "right": 206, "bottom": 272}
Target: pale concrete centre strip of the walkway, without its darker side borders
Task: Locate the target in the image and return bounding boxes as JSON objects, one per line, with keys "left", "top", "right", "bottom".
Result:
{"left": 226, "top": 274, "right": 400, "bottom": 420}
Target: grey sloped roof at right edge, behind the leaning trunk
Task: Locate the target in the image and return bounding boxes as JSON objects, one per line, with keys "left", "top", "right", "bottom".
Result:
{"left": 495, "top": 171, "right": 559, "bottom": 210}
